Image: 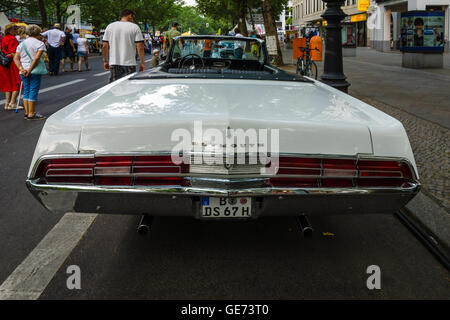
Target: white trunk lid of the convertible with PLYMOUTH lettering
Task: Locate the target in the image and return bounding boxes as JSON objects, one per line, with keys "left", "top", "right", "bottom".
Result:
{"left": 76, "top": 79, "right": 375, "bottom": 155}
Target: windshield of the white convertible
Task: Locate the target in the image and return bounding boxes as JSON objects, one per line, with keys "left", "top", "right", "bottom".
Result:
{"left": 172, "top": 38, "right": 265, "bottom": 63}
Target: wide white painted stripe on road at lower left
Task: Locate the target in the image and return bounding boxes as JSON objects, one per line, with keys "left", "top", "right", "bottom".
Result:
{"left": 0, "top": 213, "right": 97, "bottom": 300}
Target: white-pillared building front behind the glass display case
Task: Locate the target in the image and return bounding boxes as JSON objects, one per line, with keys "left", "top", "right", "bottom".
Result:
{"left": 367, "top": 0, "right": 450, "bottom": 52}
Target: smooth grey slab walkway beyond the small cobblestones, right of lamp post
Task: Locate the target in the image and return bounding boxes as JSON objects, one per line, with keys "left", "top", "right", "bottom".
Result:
{"left": 282, "top": 48, "right": 450, "bottom": 129}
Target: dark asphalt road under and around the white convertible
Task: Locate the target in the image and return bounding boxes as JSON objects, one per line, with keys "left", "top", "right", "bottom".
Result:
{"left": 0, "top": 57, "right": 450, "bottom": 299}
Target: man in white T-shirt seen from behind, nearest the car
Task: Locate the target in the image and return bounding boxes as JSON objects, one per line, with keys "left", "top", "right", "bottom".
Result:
{"left": 102, "top": 9, "right": 145, "bottom": 82}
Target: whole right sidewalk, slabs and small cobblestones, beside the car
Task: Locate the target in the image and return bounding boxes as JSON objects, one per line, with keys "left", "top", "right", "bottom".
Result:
{"left": 282, "top": 48, "right": 450, "bottom": 211}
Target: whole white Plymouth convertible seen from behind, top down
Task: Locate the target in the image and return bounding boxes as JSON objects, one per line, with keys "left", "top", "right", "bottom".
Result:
{"left": 26, "top": 36, "right": 420, "bottom": 224}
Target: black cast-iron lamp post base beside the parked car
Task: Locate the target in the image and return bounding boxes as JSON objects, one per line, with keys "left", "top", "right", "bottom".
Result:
{"left": 320, "top": 0, "right": 350, "bottom": 93}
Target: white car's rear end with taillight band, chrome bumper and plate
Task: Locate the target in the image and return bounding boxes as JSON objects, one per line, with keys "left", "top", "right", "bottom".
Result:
{"left": 27, "top": 153, "right": 420, "bottom": 219}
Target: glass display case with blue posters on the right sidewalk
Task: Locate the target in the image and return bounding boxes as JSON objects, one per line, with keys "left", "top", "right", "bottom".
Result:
{"left": 400, "top": 11, "right": 445, "bottom": 52}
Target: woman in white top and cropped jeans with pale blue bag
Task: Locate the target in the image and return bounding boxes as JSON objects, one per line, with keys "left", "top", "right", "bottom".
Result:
{"left": 14, "top": 24, "right": 47, "bottom": 120}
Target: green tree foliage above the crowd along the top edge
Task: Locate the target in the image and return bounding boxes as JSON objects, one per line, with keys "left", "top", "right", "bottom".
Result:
{"left": 12, "top": 0, "right": 288, "bottom": 34}
